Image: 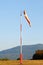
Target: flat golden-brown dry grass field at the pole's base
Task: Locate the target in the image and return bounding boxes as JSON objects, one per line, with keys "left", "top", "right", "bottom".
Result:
{"left": 0, "top": 60, "right": 43, "bottom": 65}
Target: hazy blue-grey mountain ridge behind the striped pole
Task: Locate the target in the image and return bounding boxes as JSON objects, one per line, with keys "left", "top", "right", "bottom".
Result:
{"left": 0, "top": 44, "right": 43, "bottom": 60}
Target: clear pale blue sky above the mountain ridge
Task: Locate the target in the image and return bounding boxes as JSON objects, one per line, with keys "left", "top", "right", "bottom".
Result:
{"left": 0, "top": 0, "right": 43, "bottom": 51}
